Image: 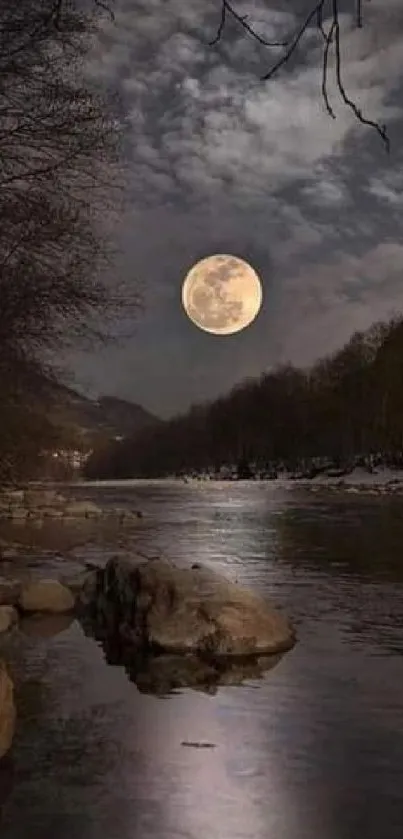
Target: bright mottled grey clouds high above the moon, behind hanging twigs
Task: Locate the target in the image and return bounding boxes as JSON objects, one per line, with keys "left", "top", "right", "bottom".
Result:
{"left": 87, "top": 0, "right": 403, "bottom": 201}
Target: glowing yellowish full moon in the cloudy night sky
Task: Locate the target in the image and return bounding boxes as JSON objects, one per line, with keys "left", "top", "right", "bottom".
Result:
{"left": 182, "top": 254, "right": 262, "bottom": 335}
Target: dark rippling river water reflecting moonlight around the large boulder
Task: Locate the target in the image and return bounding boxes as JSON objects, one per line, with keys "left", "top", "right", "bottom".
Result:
{"left": 0, "top": 482, "right": 403, "bottom": 839}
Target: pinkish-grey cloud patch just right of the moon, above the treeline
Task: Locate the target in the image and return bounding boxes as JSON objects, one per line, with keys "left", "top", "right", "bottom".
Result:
{"left": 274, "top": 242, "right": 403, "bottom": 364}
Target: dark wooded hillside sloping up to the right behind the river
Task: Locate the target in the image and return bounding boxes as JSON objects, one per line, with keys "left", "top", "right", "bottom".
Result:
{"left": 86, "top": 317, "right": 403, "bottom": 478}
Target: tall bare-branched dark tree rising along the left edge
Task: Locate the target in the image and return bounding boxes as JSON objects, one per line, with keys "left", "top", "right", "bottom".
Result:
{"left": 0, "top": 0, "right": 139, "bottom": 482}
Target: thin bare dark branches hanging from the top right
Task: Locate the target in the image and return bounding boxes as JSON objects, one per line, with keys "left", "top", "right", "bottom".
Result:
{"left": 210, "top": 0, "right": 390, "bottom": 152}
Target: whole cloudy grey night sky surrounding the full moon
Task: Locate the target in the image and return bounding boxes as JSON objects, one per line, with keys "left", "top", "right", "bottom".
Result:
{"left": 71, "top": 0, "right": 403, "bottom": 416}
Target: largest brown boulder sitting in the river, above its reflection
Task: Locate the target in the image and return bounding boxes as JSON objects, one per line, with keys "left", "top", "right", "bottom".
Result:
{"left": 79, "top": 557, "right": 295, "bottom": 656}
